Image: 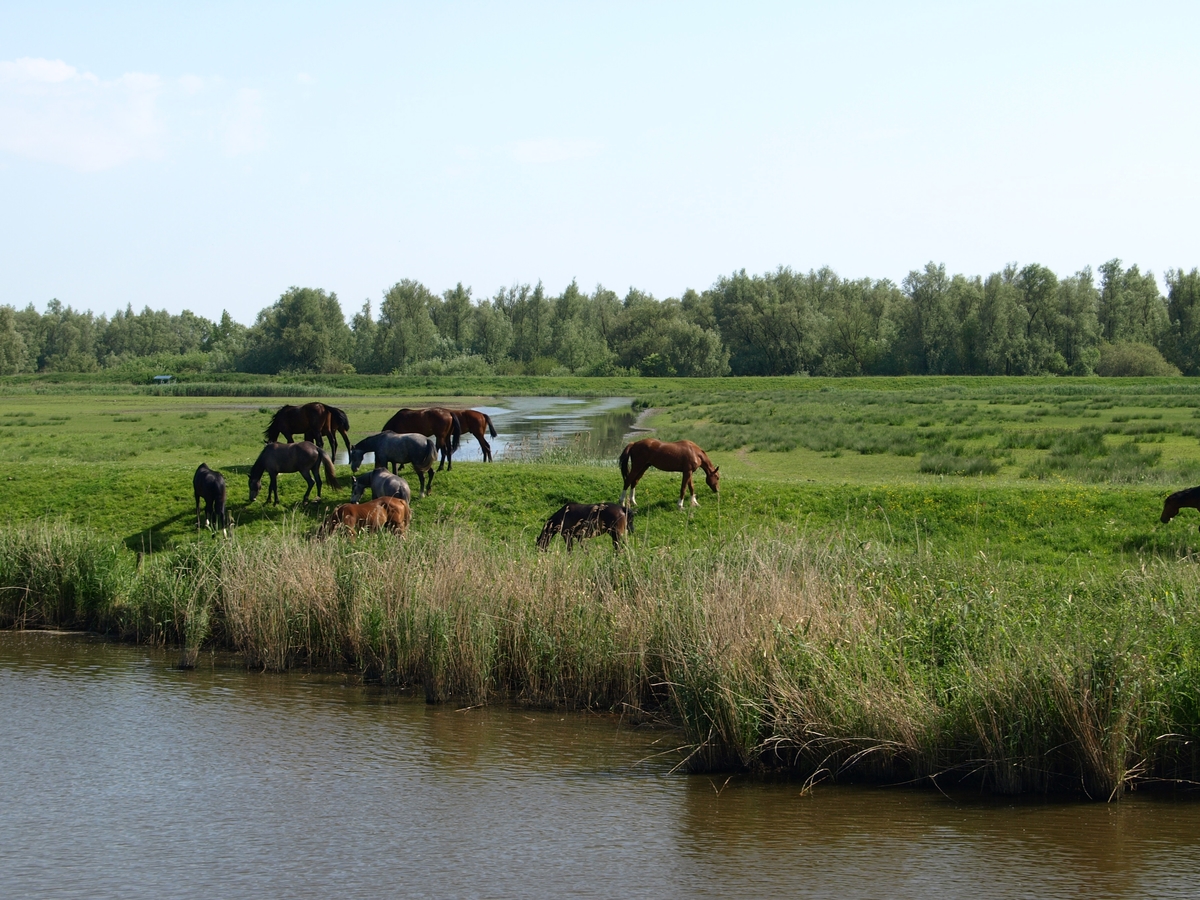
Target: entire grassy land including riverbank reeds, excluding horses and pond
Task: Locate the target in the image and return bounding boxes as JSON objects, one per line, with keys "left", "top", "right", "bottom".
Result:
{"left": 0, "top": 378, "right": 1200, "bottom": 797}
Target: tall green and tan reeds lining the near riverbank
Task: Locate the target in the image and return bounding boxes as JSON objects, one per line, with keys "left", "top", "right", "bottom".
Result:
{"left": 0, "top": 526, "right": 1200, "bottom": 799}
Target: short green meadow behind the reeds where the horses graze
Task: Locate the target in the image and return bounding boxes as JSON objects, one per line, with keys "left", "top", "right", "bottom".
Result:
{"left": 0, "top": 377, "right": 1200, "bottom": 565}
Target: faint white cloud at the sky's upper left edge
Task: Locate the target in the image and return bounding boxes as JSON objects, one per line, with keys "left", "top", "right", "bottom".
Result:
{"left": 0, "top": 58, "right": 163, "bottom": 172}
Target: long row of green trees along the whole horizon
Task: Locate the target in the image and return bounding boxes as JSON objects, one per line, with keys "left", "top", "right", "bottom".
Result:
{"left": 0, "top": 259, "right": 1200, "bottom": 377}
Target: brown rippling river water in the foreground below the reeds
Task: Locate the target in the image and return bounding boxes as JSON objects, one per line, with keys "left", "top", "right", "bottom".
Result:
{"left": 0, "top": 632, "right": 1200, "bottom": 898}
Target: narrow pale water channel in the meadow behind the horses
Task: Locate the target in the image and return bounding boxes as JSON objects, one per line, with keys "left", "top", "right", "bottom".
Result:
{"left": 337, "top": 397, "right": 637, "bottom": 463}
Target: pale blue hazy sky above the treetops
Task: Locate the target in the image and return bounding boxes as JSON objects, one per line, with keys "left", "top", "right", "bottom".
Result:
{"left": 0, "top": 0, "right": 1200, "bottom": 324}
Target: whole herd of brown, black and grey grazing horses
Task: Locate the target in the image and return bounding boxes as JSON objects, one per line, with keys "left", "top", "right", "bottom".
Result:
{"left": 192, "top": 402, "right": 1200, "bottom": 551}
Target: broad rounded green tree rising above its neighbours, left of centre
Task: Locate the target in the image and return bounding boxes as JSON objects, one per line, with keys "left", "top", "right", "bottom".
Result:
{"left": 241, "top": 287, "right": 350, "bottom": 374}
